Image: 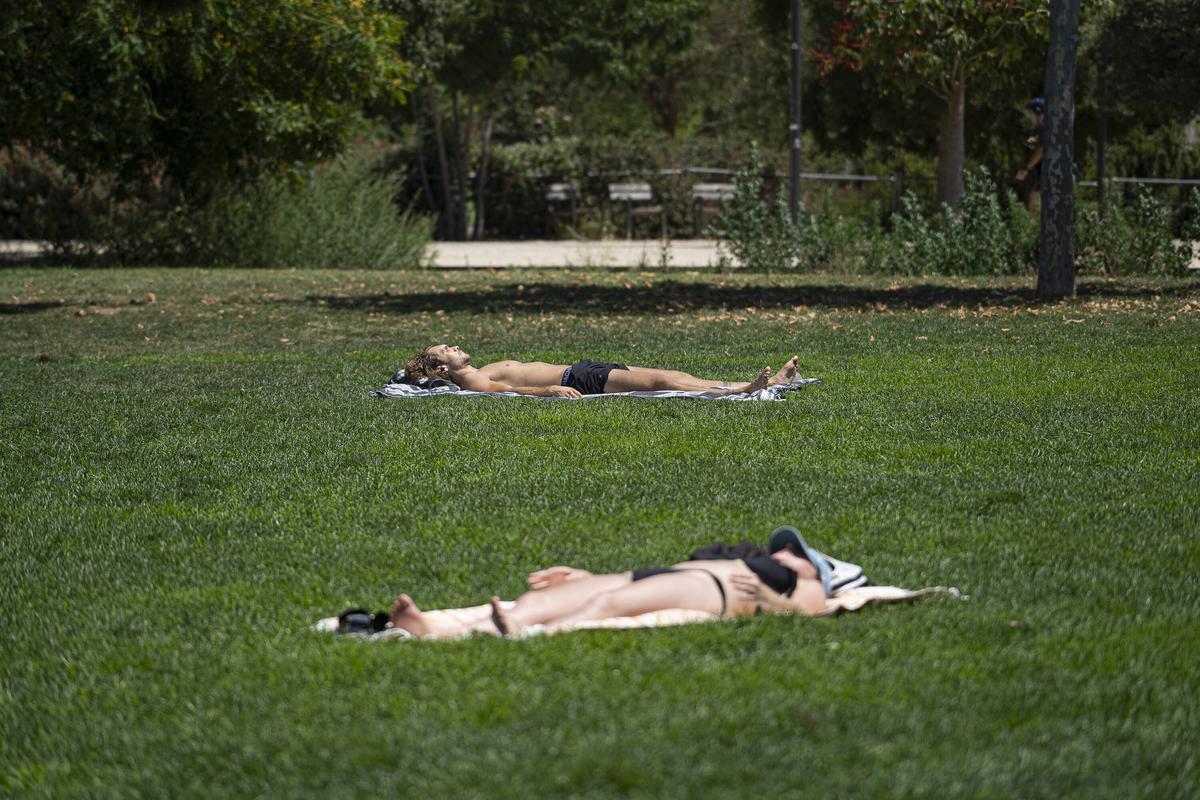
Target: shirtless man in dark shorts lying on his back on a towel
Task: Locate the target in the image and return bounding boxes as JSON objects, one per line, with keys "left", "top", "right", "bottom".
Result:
{"left": 404, "top": 344, "right": 797, "bottom": 397}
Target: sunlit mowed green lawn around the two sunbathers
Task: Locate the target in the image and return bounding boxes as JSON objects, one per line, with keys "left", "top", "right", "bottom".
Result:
{"left": 0, "top": 267, "right": 1200, "bottom": 798}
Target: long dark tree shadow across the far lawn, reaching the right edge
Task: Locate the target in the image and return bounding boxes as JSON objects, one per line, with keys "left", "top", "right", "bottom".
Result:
{"left": 306, "top": 281, "right": 1200, "bottom": 313}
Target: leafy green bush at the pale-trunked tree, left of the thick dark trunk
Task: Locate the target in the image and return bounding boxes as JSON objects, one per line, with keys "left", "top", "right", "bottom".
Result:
{"left": 889, "top": 169, "right": 1037, "bottom": 275}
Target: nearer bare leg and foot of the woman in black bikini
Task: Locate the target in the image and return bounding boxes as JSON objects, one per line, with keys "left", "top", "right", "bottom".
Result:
{"left": 492, "top": 571, "right": 724, "bottom": 634}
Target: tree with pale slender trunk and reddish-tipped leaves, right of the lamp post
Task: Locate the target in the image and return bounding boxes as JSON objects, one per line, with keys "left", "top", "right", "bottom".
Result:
{"left": 815, "top": 0, "right": 1048, "bottom": 209}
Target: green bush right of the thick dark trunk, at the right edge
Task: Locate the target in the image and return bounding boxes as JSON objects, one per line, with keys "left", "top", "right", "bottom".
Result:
{"left": 1075, "top": 187, "right": 1200, "bottom": 275}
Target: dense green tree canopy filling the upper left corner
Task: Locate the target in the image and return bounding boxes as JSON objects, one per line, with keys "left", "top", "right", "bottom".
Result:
{"left": 0, "top": 0, "right": 408, "bottom": 192}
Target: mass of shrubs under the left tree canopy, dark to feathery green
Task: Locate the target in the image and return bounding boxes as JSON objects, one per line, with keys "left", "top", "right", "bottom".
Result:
{"left": 12, "top": 153, "right": 430, "bottom": 269}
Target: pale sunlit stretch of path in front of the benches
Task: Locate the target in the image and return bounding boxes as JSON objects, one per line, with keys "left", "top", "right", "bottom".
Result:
{"left": 430, "top": 239, "right": 720, "bottom": 269}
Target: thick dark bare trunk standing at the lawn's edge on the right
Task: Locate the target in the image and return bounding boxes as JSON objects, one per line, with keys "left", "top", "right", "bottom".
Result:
{"left": 1038, "top": 0, "right": 1080, "bottom": 297}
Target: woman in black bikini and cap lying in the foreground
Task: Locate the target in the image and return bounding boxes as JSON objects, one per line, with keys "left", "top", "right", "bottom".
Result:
{"left": 390, "top": 527, "right": 833, "bottom": 638}
